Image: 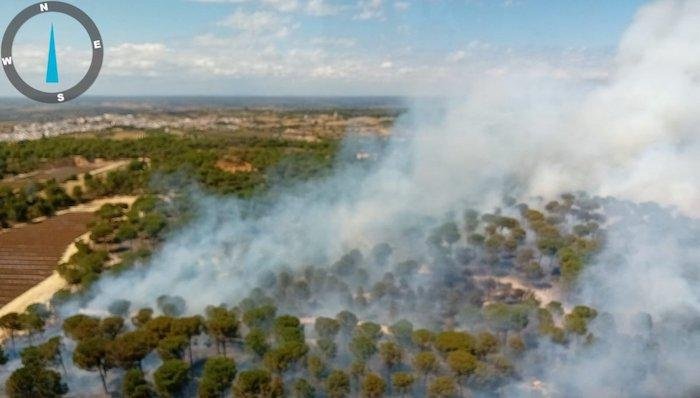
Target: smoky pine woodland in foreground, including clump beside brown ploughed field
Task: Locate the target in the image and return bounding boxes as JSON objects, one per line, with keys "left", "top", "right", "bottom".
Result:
{"left": 0, "top": 173, "right": 606, "bottom": 397}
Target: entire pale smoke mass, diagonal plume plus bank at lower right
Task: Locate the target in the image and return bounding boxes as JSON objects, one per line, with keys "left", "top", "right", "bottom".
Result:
{"left": 58, "top": 1, "right": 700, "bottom": 396}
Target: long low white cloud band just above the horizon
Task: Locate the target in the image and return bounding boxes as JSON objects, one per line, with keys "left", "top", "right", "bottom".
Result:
{"left": 78, "top": 35, "right": 610, "bottom": 95}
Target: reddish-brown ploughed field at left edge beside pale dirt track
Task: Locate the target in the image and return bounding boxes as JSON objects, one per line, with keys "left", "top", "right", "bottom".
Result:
{"left": 0, "top": 213, "right": 93, "bottom": 306}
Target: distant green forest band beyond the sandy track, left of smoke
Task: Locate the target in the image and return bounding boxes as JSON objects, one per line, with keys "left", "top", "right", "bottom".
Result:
{"left": 0, "top": 131, "right": 337, "bottom": 196}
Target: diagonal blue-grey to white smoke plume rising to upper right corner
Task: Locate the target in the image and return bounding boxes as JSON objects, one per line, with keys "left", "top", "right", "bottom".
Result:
{"left": 79, "top": 1, "right": 700, "bottom": 308}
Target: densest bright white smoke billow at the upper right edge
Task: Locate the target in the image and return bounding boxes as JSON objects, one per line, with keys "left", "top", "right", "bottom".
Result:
{"left": 580, "top": 1, "right": 700, "bottom": 216}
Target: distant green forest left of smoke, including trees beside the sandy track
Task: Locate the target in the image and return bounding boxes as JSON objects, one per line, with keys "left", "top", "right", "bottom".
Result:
{"left": 0, "top": 131, "right": 338, "bottom": 227}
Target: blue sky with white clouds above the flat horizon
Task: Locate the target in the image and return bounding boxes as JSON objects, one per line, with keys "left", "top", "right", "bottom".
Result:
{"left": 0, "top": 0, "right": 646, "bottom": 95}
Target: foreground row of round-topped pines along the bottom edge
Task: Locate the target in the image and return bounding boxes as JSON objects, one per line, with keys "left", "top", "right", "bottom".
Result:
{"left": 0, "top": 290, "right": 596, "bottom": 398}
